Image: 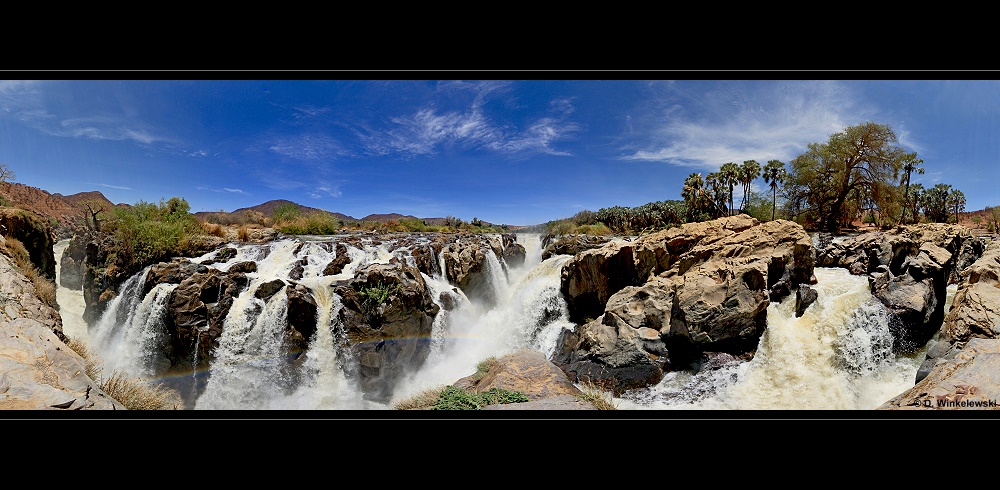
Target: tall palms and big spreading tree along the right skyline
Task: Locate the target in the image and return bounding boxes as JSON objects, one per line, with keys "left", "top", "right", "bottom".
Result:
{"left": 672, "top": 122, "right": 966, "bottom": 232}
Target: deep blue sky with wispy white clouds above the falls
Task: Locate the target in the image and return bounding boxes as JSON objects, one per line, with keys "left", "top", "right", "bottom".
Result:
{"left": 0, "top": 77, "right": 1000, "bottom": 225}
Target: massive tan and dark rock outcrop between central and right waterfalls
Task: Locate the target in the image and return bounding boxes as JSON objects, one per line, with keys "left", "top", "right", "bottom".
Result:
{"left": 553, "top": 215, "right": 814, "bottom": 394}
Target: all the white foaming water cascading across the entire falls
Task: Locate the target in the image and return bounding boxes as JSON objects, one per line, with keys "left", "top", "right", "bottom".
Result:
{"left": 48, "top": 234, "right": 954, "bottom": 410}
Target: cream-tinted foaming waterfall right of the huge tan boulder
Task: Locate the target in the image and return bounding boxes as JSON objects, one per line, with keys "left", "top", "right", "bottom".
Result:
{"left": 619, "top": 267, "right": 922, "bottom": 410}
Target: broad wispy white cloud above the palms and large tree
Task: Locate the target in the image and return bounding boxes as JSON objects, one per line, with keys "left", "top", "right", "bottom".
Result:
{"left": 623, "top": 81, "right": 864, "bottom": 169}
